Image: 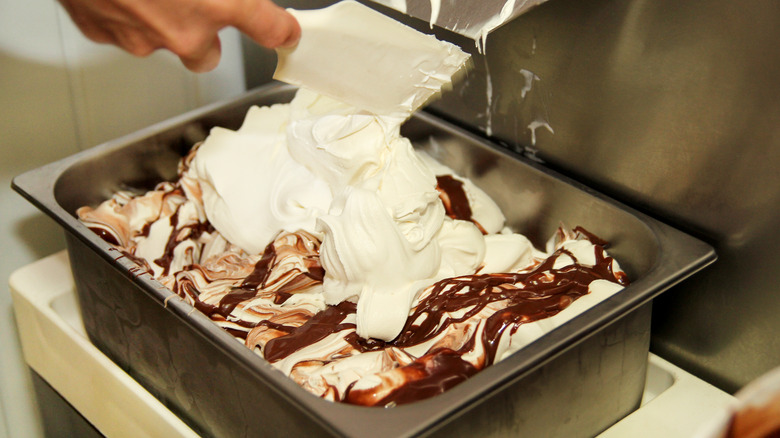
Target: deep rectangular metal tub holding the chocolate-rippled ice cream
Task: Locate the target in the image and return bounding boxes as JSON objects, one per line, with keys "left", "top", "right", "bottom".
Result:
{"left": 13, "top": 84, "right": 715, "bottom": 438}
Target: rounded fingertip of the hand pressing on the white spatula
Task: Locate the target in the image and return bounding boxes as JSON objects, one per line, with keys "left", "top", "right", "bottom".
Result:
{"left": 233, "top": 0, "right": 301, "bottom": 49}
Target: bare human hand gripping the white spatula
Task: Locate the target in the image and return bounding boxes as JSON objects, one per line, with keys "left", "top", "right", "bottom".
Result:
{"left": 59, "top": 0, "right": 301, "bottom": 72}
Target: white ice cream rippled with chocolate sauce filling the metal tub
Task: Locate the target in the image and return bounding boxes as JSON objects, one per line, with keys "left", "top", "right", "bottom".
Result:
{"left": 78, "top": 89, "right": 626, "bottom": 406}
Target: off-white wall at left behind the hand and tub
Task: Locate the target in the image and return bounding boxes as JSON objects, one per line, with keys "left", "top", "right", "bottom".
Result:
{"left": 0, "top": 0, "right": 244, "bottom": 438}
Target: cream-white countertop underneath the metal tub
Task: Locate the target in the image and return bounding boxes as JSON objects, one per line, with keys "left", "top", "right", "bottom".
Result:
{"left": 9, "top": 251, "right": 735, "bottom": 438}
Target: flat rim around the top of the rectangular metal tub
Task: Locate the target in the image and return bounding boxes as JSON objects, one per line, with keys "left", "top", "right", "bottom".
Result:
{"left": 12, "top": 84, "right": 716, "bottom": 436}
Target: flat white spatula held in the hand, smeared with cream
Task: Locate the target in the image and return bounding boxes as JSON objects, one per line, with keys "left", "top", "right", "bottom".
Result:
{"left": 274, "top": 0, "right": 469, "bottom": 118}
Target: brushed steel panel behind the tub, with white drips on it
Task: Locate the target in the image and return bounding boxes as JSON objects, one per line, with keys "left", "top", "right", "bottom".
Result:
{"left": 244, "top": 0, "right": 780, "bottom": 391}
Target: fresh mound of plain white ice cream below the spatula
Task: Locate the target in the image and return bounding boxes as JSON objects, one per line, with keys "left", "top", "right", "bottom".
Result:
{"left": 189, "top": 89, "right": 531, "bottom": 340}
